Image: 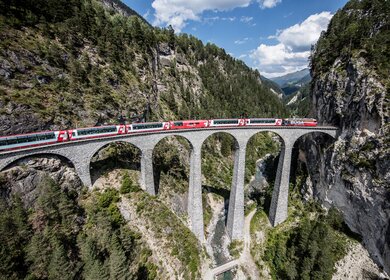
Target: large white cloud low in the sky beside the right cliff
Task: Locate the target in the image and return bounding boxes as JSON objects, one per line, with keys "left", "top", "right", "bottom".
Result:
{"left": 250, "top": 12, "right": 332, "bottom": 78}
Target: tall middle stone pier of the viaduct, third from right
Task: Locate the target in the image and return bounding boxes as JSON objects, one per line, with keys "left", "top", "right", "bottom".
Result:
{"left": 187, "top": 142, "right": 205, "bottom": 243}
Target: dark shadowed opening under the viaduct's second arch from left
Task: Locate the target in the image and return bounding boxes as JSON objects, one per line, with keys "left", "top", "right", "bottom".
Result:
{"left": 86, "top": 139, "right": 141, "bottom": 187}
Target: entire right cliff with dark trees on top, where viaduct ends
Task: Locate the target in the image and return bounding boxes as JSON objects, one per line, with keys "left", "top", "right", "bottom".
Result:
{"left": 305, "top": 1, "right": 390, "bottom": 272}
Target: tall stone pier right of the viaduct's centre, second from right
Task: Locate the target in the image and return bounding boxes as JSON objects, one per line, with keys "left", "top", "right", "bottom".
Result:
{"left": 227, "top": 139, "right": 248, "bottom": 240}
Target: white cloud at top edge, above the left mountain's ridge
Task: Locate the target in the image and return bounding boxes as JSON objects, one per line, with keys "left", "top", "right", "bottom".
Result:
{"left": 152, "top": 0, "right": 252, "bottom": 32}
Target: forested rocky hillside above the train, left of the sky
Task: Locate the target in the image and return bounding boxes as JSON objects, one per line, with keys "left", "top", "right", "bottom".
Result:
{"left": 0, "top": 0, "right": 286, "bottom": 135}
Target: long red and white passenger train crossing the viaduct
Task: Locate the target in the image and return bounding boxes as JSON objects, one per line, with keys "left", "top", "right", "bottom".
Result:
{"left": 0, "top": 118, "right": 317, "bottom": 151}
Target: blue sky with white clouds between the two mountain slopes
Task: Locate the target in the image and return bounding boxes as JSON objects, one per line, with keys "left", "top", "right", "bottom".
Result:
{"left": 122, "top": 0, "right": 348, "bottom": 78}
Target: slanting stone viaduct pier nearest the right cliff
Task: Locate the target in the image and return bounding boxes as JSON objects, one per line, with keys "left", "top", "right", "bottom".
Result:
{"left": 269, "top": 139, "right": 294, "bottom": 226}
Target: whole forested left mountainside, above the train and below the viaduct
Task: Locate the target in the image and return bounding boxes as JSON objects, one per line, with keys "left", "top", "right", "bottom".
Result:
{"left": 0, "top": 0, "right": 288, "bottom": 279}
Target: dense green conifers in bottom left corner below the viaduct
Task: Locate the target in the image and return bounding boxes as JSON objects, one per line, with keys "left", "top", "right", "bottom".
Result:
{"left": 0, "top": 177, "right": 156, "bottom": 279}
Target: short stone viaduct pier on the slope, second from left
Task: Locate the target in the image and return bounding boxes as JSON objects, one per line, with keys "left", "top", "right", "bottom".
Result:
{"left": 140, "top": 148, "right": 156, "bottom": 195}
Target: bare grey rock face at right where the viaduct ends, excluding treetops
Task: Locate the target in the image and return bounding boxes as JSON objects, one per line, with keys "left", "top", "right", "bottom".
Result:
{"left": 304, "top": 53, "right": 390, "bottom": 272}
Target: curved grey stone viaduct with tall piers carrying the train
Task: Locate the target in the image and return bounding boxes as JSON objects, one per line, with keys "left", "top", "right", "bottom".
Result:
{"left": 0, "top": 127, "right": 337, "bottom": 242}
